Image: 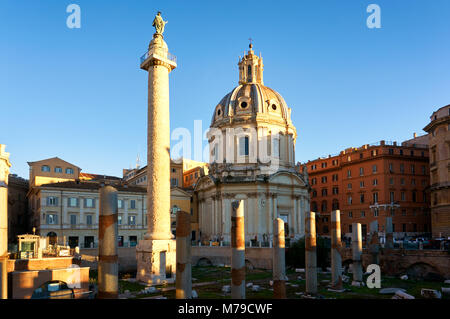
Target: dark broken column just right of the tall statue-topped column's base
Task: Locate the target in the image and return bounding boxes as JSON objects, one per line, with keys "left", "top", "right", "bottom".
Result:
{"left": 175, "top": 211, "right": 192, "bottom": 299}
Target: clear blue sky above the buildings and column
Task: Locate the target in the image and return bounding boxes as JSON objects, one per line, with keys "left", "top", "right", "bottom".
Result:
{"left": 0, "top": 0, "right": 450, "bottom": 178}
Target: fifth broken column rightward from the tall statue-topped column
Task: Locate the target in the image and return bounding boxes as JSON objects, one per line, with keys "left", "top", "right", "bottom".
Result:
{"left": 331, "top": 210, "right": 343, "bottom": 290}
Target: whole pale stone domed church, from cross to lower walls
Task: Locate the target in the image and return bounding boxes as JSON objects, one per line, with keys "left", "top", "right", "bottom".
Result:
{"left": 194, "top": 44, "right": 310, "bottom": 242}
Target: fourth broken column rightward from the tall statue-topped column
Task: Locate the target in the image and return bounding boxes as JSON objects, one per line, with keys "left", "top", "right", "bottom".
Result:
{"left": 305, "top": 211, "right": 317, "bottom": 294}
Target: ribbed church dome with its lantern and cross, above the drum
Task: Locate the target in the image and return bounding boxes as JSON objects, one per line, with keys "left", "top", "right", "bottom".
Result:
{"left": 211, "top": 45, "right": 293, "bottom": 131}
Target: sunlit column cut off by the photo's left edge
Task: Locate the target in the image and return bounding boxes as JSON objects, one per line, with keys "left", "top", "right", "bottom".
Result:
{"left": 0, "top": 144, "right": 11, "bottom": 299}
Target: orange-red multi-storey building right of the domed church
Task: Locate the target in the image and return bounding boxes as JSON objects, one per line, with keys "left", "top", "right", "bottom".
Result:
{"left": 305, "top": 139, "right": 431, "bottom": 238}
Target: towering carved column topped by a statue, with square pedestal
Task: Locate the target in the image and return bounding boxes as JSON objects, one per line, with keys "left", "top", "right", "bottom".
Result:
{"left": 136, "top": 12, "right": 177, "bottom": 284}
